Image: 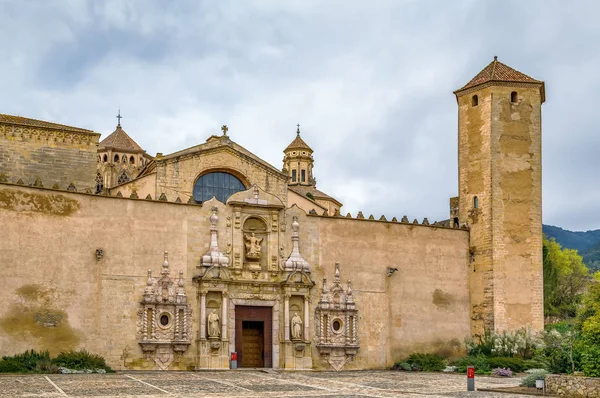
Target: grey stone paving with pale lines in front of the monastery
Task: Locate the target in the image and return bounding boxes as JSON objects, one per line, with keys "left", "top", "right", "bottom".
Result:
{"left": 0, "top": 370, "right": 528, "bottom": 398}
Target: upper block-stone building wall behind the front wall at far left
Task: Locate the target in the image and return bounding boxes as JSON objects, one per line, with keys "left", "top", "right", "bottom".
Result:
{"left": 0, "top": 124, "right": 100, "bottom": 192}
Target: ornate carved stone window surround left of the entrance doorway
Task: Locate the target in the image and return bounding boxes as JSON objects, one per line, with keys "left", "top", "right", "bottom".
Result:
{"left": 136, "top": 252, "right": 192, "bottom": 370}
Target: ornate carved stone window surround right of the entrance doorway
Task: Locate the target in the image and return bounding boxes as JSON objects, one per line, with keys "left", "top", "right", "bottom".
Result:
{"left": 315, "top": 263, "right": 360, "bottom": 371}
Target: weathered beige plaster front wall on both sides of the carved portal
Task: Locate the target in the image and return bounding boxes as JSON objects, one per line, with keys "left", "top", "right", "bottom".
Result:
{"left": 0, "top": 184, "right": 470, "bottom": 369}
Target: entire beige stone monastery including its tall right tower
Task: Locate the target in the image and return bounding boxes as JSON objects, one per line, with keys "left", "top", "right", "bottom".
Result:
{"left": 0, "top": 59, "right": 545, "bottom": 370}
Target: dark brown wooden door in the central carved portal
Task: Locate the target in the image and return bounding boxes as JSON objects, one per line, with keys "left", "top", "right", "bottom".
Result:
{"left": 235, "top": 306, "right": 273, "bottom": 368}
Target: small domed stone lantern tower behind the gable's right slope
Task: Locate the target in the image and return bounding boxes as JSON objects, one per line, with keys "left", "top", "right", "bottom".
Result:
{"left": 283, "top": 125, "right": 314, "bottom": 185}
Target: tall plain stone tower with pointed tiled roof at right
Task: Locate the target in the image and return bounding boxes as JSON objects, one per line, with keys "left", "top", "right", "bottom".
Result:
{"left": 454, "top": 57, "right": 545, "bottom": 334}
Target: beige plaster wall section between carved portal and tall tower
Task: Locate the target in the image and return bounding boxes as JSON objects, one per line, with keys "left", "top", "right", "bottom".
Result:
{"left": 309, "top": 217, "right": 470, "bottom": 369}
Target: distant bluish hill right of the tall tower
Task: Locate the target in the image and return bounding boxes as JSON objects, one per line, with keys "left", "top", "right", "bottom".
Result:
{"left": 542, "top": 225, "right": 600, "bottom": 271}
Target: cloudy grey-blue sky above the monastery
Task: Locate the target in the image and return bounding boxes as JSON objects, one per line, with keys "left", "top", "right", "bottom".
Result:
{"left": 0, "top": 0, "right": 600, "bottom": 230}
